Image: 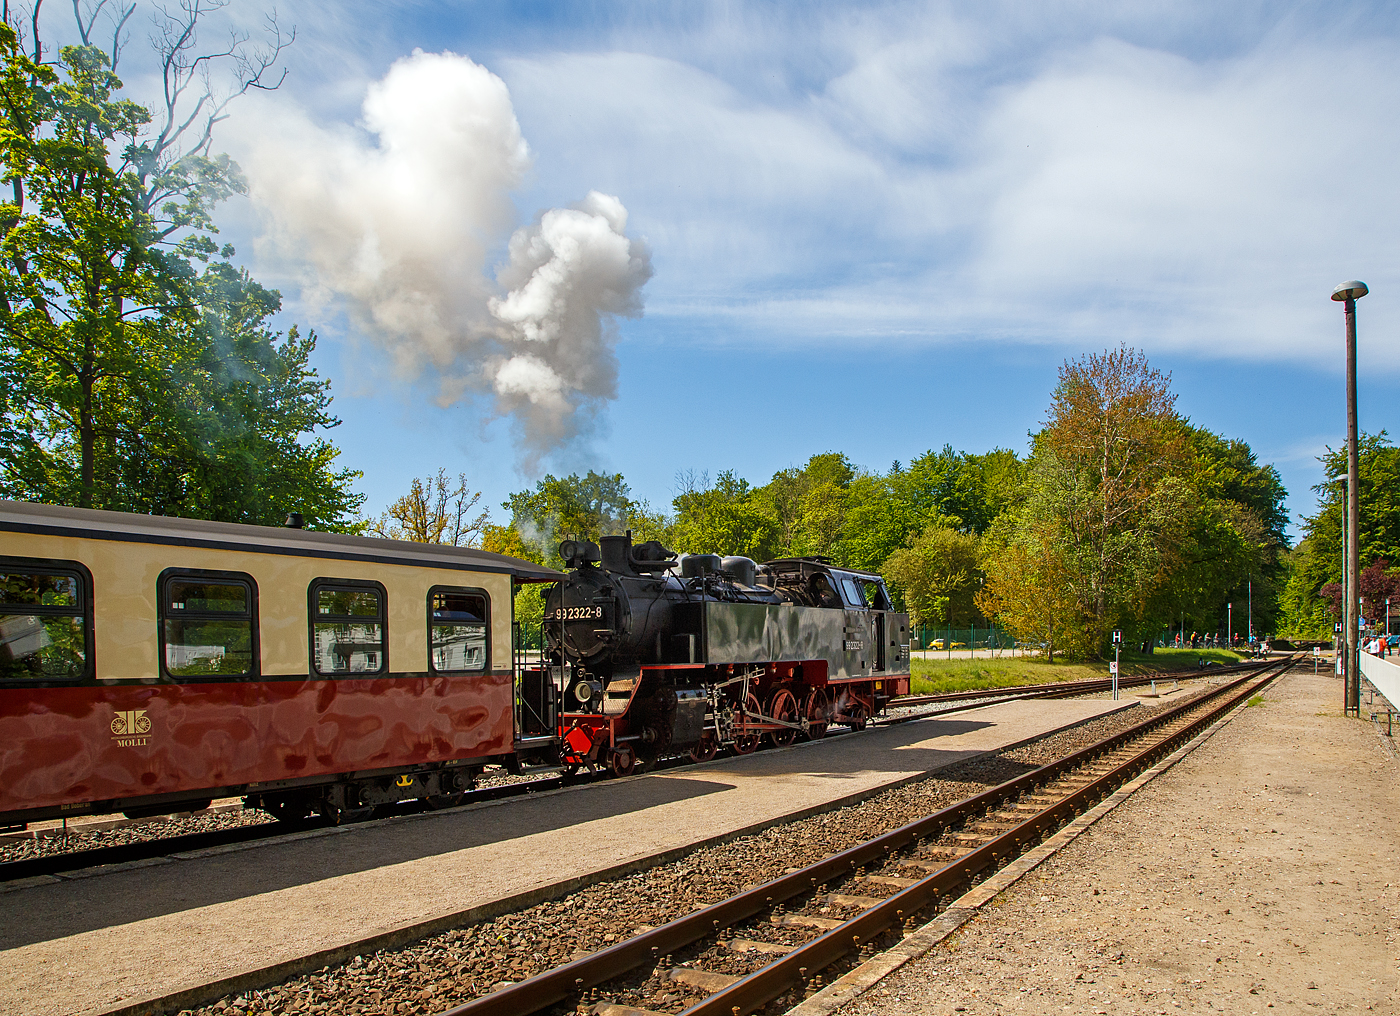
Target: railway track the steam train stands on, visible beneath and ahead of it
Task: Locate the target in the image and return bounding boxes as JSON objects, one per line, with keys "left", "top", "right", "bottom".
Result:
{"left": 0, "top": 663, "right": 1263, "bottom": 884}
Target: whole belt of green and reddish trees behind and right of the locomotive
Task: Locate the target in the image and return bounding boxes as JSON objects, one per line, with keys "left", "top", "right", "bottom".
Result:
{"left": 484, "top": 347, "right": 1288, "bottom": 661}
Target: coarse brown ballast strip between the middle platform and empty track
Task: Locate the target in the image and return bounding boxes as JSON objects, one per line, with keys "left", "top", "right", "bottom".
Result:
{"left": 175, "top": 685, "right": 1215, "bottom": 1016}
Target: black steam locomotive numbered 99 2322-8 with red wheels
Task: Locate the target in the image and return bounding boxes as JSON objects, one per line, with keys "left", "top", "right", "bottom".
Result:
{"left": 522, "top": 533, "right": 910, "bottom": 775}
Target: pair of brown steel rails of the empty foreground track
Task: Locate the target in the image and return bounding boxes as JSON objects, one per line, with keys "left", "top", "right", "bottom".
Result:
{"left": 441, "top": 658, "right": 1294, "bottom": 1016}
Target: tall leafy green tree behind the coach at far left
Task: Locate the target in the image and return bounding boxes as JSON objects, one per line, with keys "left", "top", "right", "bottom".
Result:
{"left": 0, "top": 25, "right": 363, "bottom": 530}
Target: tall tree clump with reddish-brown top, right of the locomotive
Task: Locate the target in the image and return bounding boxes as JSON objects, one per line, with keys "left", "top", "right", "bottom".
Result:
{"left": 980, "top": 347, "right": 1287, "bottom": 656}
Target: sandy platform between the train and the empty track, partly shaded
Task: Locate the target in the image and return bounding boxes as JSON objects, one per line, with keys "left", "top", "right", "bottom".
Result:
{"left": 0, "top": 700, "right": 1135, "bottom": 1015}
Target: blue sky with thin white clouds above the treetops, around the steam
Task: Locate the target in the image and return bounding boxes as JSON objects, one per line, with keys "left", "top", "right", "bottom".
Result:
{"left": 156, "top": 3, "right": 1400, "bottom": 540}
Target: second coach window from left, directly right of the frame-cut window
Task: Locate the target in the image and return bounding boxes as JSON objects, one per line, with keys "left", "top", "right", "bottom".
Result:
{"left": 160, "top": 571, "right": 258, "bottom": 677}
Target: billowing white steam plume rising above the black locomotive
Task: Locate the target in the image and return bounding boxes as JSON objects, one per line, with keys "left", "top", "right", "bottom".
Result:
{"left": 244, "top": 52, "right": 651, "bottom": 469}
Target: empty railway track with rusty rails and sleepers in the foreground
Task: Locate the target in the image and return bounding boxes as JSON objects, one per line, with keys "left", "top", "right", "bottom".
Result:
{"left": 444, "top": 658, "right": 1295, "bottom": 1016}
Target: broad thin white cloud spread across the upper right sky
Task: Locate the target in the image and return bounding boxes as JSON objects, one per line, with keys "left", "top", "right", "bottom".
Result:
{"left": 501, "top": 14, "right": 1400, "bottom": 367}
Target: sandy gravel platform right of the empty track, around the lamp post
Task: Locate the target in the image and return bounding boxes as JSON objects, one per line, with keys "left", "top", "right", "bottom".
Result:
{"left": 843, "top": 669, "right": 1400, "bottom": 1016}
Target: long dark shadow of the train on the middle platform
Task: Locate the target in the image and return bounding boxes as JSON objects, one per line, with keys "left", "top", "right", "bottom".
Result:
{"left": 0, "top": 718, "right": 1014, "bottom": 950}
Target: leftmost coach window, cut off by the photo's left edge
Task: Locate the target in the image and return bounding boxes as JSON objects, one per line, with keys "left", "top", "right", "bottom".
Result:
{"left": 0, "top": 558, "right": 92, "bottom": 680}
